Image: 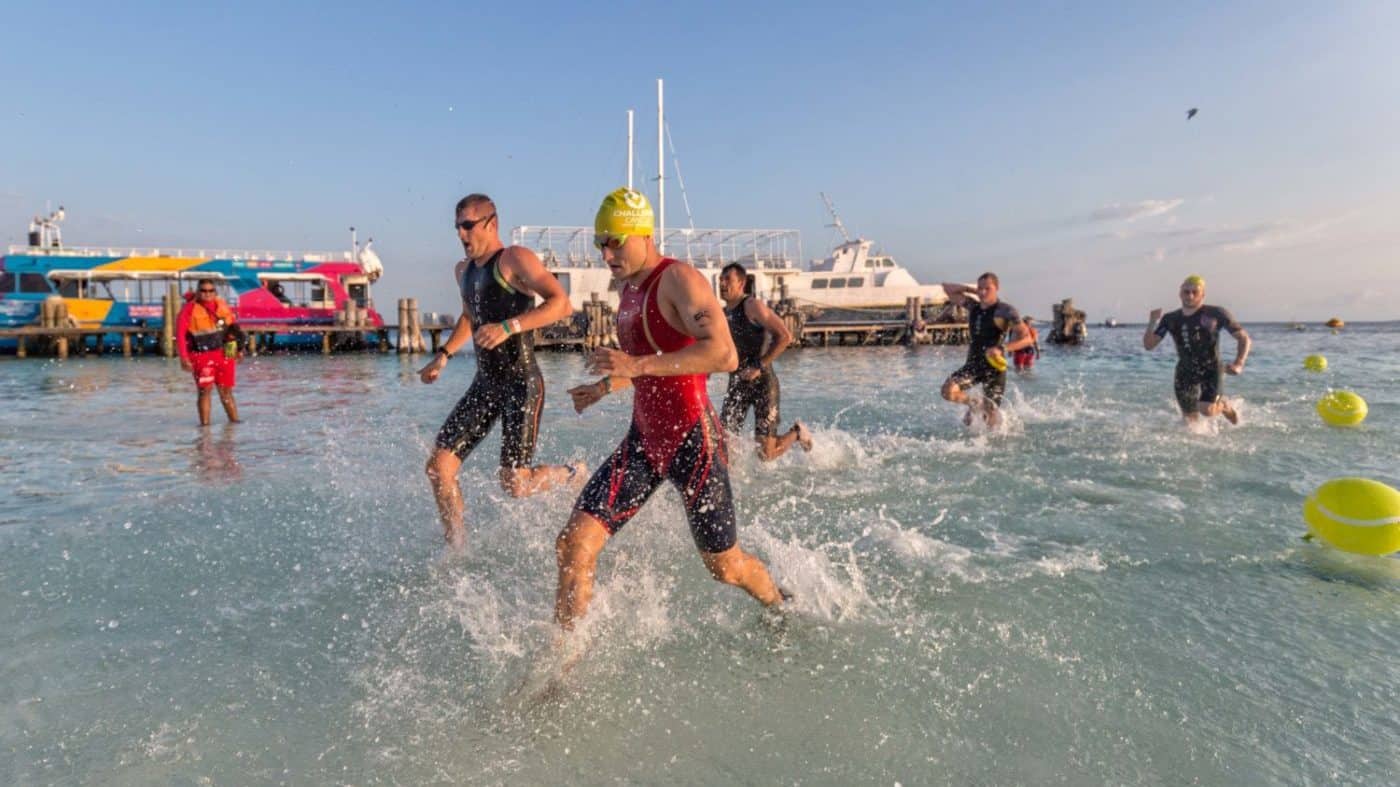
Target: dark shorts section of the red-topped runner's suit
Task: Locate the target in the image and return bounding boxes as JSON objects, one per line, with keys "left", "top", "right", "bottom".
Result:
{"left": 574, "top": 410, "right": 738, "bottom": 553}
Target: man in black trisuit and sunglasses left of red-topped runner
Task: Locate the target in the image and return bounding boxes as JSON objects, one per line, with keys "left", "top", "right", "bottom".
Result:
{"left": 419, "top": 195, "right": 587, "bottom": 550}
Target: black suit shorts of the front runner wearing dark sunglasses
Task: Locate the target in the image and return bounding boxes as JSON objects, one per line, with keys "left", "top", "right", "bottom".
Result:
{"left": 437, "top": 365, "right": 545, "bottom": 468}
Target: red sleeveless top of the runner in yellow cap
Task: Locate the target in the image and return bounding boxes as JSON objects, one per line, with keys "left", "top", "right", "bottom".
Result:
{"left": 617, "top": 258, "right": 710, "bottom": 469}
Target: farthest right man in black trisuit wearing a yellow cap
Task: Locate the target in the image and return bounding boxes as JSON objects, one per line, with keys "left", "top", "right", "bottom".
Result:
{"left": 1142, "top": 276, "right": 1250, "bottom": 423}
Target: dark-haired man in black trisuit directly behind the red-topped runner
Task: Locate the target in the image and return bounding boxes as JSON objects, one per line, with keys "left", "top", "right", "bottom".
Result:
{"left": 720, "top": 262, "right": 812, "bottom": 462}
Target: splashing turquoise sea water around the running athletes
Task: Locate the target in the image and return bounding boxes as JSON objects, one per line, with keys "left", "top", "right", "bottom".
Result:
{"left": 0, "top": 323, "right": 1400, "bottom": 784}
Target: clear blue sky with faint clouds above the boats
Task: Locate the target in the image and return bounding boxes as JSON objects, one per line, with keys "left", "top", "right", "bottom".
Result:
{"left": 0, "top": 1, "right": 1400, "bottom": 321}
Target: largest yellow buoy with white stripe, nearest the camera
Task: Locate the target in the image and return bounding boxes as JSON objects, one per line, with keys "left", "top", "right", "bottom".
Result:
{"left": 1303, "top": 478, "right": 1400, "bottom": 555}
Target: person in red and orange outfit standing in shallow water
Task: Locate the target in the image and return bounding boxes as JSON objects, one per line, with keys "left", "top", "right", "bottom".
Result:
{"left": 175, "top": 279, "right": 241, "bottom": 426}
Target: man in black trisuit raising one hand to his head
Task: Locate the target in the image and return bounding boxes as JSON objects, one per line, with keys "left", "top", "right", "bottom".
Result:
{"left": 942, "top": 273, "right": 1035, "bottom": 426}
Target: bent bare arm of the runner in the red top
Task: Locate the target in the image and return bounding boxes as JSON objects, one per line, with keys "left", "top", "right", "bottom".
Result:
{"left": 588, "top": 265, "right": 739, "bottom": 378}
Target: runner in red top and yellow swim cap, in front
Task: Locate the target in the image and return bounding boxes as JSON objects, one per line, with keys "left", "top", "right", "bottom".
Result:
{"left": 554, "top": 189, "right": 783, "bottom": 630}
